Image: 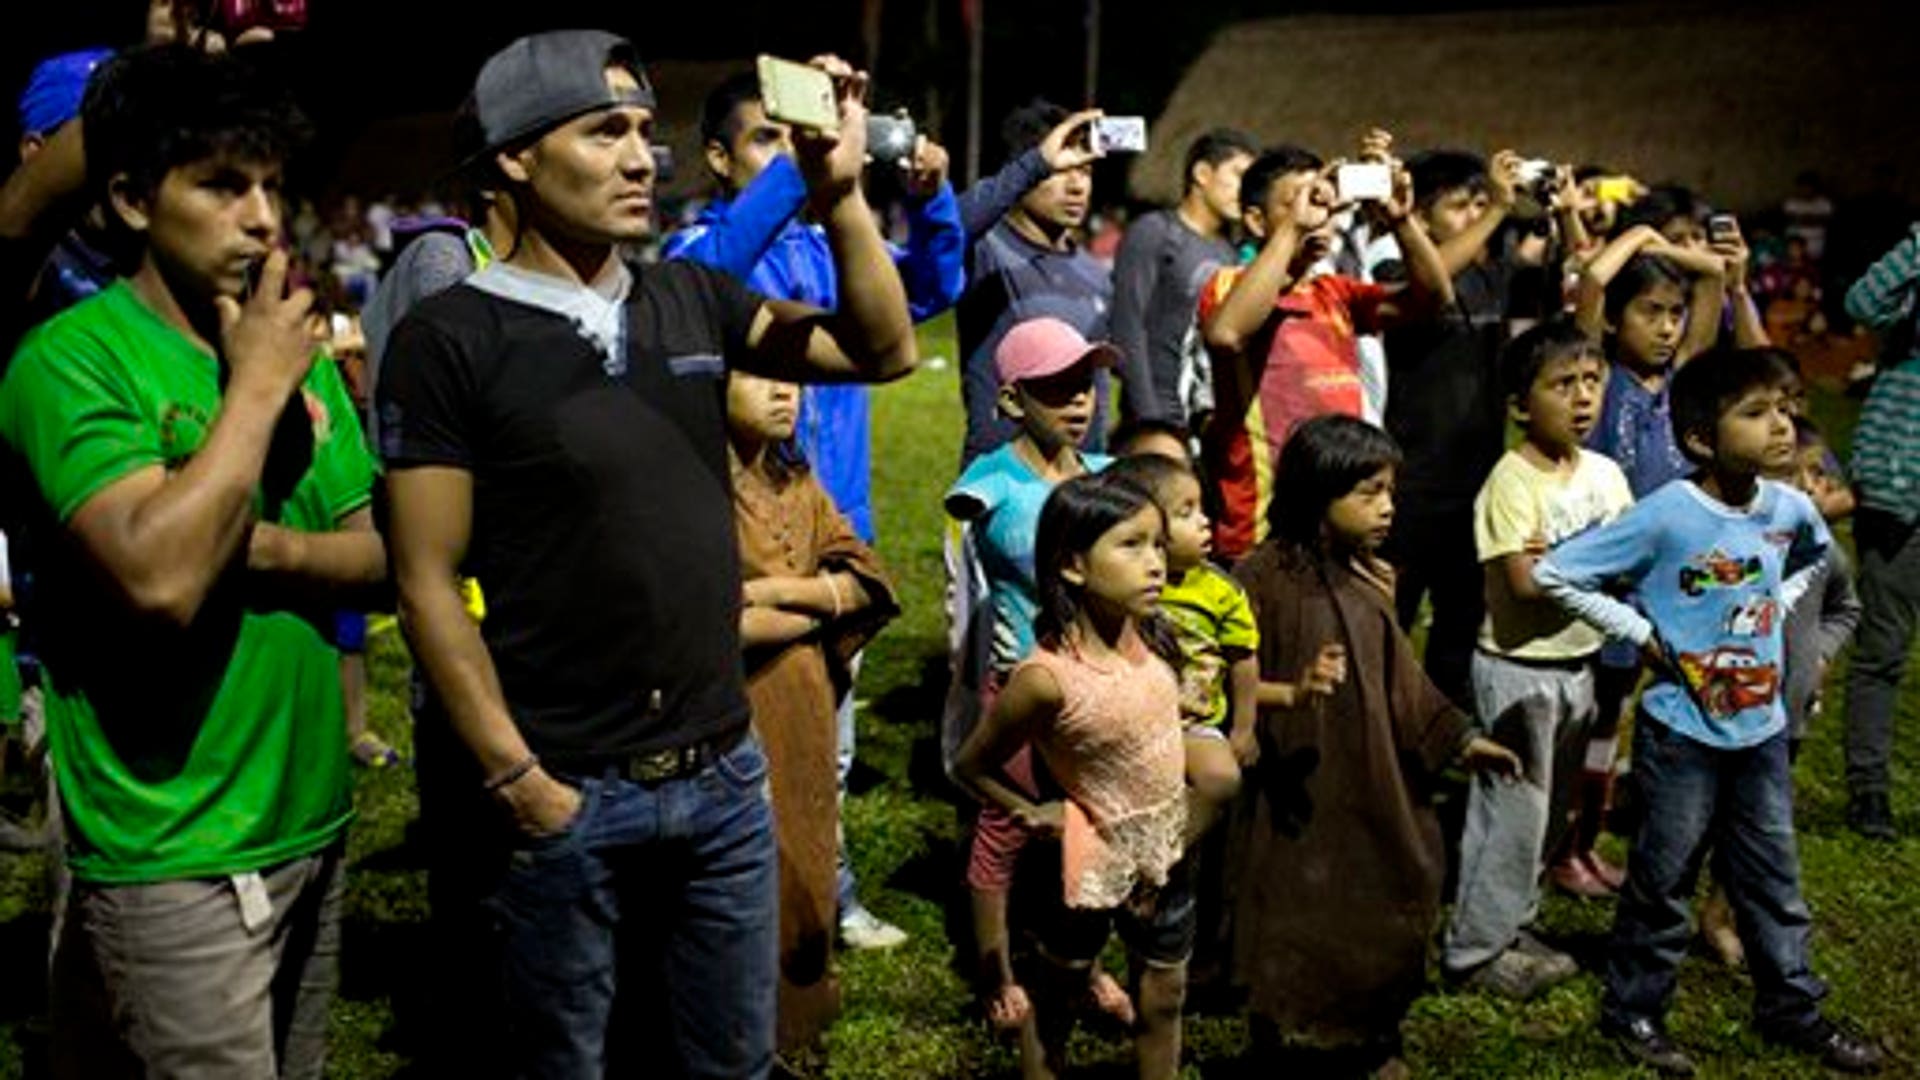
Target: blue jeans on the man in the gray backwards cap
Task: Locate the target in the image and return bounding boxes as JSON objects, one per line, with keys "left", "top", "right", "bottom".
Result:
{"left": 484, "top": 736, "right": 780, "bottom": 1080}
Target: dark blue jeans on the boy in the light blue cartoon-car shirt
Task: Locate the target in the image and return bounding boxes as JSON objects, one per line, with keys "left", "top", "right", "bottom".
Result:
{"left": 1601, "top": 713, "right": 1826, "bottom": 1030}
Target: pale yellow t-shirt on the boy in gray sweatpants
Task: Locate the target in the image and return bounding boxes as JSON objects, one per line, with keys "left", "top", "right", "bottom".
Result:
{"left": 1473, "top": 450, "right": 1634, "bottom": 659}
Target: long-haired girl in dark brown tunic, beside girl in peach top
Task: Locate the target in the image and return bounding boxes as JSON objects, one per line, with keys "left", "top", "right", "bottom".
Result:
{"left": 1235, "top": 415, "right": 1519, "bottom": 1076}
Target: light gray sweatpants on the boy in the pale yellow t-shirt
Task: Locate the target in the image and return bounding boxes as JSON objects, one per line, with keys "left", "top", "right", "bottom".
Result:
{"left": 1442, "top": 651, "right": 1599, "bottom": 970}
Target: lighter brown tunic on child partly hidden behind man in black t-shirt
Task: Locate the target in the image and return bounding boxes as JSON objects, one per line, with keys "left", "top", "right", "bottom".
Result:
{"left": 733, "top": 449, "right": 899, "bottom": 1049}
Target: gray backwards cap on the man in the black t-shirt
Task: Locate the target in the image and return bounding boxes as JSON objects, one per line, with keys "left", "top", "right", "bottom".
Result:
{"left": 468, "top": 31, "right": 653, "bottom": 154}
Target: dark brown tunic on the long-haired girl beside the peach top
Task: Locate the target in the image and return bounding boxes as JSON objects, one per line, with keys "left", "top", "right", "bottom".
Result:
{"left": 1233, "top": 540, "right": 1471, "bottom": 1047}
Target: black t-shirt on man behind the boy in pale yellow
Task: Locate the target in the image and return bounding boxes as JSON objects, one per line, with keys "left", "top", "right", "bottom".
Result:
{"left": 1386, "top": 247, "right": 1513, "bottom": 513}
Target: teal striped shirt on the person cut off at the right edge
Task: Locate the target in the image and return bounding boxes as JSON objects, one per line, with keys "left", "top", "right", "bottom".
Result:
{"left": 1847, "top": 225, "right": 1920, "bottom": 523}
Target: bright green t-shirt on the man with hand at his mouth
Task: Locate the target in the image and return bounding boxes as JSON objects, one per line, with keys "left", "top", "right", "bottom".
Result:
{"left": 0, "top": 282, "right": 374, "bottom": 884}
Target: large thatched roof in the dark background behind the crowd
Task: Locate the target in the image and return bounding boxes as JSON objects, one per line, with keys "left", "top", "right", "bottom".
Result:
{"left": 1131, "top": 0, "right": 1920, "bottom": 208}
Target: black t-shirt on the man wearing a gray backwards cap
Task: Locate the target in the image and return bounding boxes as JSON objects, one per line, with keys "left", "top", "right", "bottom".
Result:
{"left": 378, "top": 261, "right": 760, "bottom": 769}
